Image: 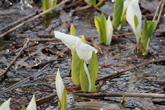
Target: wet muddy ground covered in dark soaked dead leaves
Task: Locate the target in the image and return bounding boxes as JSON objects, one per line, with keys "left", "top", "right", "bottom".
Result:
{"left": 0, "top": 1, "right": 165, "bottom": 110}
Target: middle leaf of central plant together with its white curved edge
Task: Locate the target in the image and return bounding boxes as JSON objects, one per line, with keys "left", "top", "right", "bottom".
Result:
{"left": 80, "top": 60, "right": 91, "bottom": 92}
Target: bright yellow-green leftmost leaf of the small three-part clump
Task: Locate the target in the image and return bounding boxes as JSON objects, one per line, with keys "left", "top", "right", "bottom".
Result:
{"left": 95, "top": 16, "right": 104, "bottom": 43}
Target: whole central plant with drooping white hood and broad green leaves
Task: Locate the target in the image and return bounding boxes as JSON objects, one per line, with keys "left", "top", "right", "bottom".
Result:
{"left": 54, "top": 31, "right": 98, "bottom": 92}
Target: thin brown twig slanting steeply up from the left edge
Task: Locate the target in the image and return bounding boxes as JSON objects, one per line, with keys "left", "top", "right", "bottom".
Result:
{"left": 0, "top": 38, "right": 29, "bottom": 77}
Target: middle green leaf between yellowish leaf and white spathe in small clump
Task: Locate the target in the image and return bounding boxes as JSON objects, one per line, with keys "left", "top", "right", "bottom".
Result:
{"left": 101, "top": 12, "right": 107, "bottom": 44}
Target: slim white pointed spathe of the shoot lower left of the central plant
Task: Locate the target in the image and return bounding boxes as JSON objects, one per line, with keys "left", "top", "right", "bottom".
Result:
{"left": 56, "top": 69, "right": 64, "bottom": 103}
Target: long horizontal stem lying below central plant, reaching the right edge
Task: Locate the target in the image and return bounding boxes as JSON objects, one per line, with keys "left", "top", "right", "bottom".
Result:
{"left": 73, "top": 92, "right": 165, "bottom": 98}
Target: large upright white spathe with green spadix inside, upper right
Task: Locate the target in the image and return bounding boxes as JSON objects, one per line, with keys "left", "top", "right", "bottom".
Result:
{"left": 126, "top": 0, "right": 142, "bottom": 43}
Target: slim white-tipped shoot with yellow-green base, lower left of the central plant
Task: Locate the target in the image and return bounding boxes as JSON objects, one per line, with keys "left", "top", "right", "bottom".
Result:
{"left": 56, "top": 69, "right": 67, "bottom": 110}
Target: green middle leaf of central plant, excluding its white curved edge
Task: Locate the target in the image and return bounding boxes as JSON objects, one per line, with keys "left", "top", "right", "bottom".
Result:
{"left": 80, "top": 60, "right": 89, "bottom": 92}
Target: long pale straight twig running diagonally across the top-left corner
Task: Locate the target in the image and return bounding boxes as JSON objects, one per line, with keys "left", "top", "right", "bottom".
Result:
{"left": 0, "top": 0, "right": 69, "bottom": 38}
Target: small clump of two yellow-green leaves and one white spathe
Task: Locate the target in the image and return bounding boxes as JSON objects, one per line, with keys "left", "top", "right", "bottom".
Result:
{"left": 94, "top": 13, "right": 113, "bottom": 45}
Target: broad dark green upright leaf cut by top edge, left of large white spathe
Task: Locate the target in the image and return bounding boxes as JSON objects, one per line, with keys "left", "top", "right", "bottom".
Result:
{"left": 113, "top": 0, "right": 124, "bottom": 29}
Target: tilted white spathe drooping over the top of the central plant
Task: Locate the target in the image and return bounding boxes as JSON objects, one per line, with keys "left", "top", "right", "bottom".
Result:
{"left": 54, "top": 31, "right": 97, "bottom": 62}
